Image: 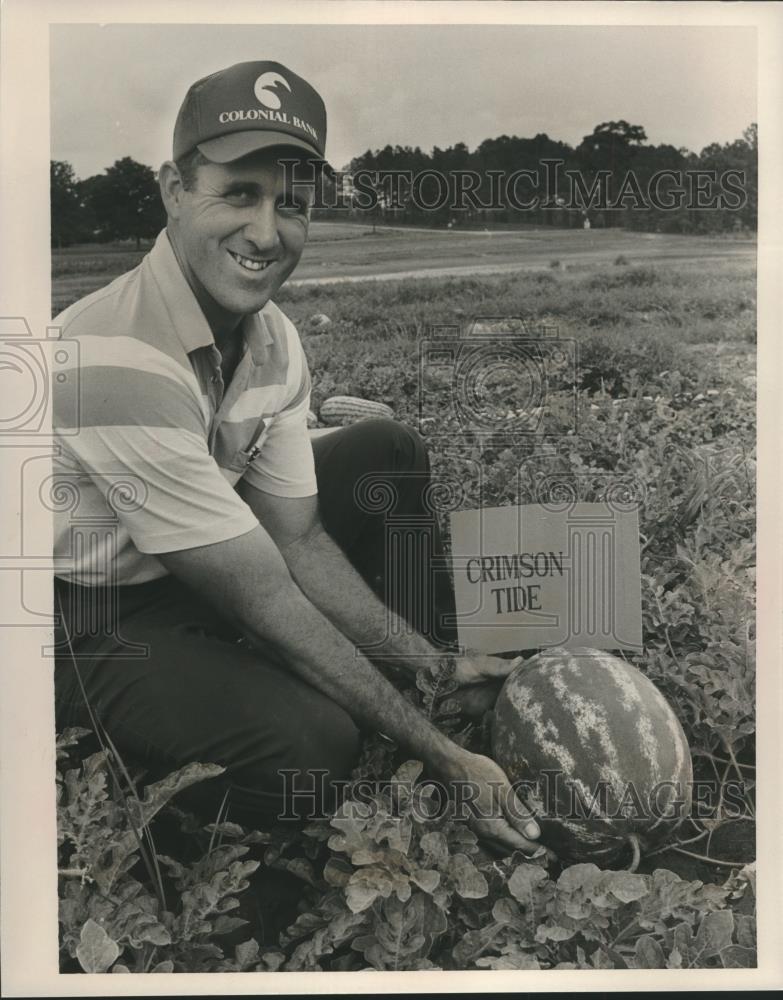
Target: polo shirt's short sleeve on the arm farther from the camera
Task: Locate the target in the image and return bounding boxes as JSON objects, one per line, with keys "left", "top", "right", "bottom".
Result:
{"left": 243, "top": 337, "right": 318, "bottom": 497}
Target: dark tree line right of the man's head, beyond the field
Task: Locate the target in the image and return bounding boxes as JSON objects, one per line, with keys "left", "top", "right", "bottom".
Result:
{"left": 344, "top": 120, "right": 758, "bottom": 233}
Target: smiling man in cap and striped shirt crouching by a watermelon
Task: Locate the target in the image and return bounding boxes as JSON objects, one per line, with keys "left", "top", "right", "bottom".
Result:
{"left": 50, "top": 62, "right": 539, "bottom": 852}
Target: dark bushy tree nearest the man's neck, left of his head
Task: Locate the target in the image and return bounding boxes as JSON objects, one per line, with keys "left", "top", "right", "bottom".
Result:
{"left": 82, "top": 156, "right": 166, "bottom": 250}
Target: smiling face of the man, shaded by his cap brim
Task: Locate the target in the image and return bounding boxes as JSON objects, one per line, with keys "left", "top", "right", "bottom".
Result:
{"left": 174, "top": 149, "right": 313, "bottom": 316}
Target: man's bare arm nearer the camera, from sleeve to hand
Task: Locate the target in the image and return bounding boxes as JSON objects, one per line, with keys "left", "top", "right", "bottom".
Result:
{"left": 159, "top": 525, "right": 539, "bottom": 852}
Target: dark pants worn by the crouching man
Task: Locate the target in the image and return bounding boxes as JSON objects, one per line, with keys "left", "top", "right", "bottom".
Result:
{"left": 55, "top": 420, "right": 456, "bottom": 826}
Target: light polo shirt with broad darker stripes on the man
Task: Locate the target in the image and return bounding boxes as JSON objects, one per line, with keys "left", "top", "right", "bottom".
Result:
{"left": 51, "top": 230, "right": 317, "bottom": 586}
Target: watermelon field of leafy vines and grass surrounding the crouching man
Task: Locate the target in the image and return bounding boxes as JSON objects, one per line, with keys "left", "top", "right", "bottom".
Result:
{"left": 54, "top": 225, "right": 756, "bottom": 971}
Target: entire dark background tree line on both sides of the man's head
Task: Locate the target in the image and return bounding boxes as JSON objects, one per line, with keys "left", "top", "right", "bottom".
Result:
{"left": 50, "top": 121, "right": 758, "bottom": 248}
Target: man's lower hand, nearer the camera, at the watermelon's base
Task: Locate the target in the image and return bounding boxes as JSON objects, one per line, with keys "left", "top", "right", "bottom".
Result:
{"left": 444, "top": 750, "right": 554, "bottom": 858}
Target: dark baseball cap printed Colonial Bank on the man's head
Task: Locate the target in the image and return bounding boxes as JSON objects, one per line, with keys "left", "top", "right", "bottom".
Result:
{"left": 174, "top": 61, "right": 326, "bottom": 163}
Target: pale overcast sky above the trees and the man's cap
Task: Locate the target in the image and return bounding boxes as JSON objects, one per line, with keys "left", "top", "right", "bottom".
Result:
{"left": 50, "top": 24, "right": 756, "bottom": 178}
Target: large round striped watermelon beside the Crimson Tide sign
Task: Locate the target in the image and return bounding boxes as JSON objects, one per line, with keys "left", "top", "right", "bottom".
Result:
{"left": 491, "top": 647, "right": 693, "bottom": 867}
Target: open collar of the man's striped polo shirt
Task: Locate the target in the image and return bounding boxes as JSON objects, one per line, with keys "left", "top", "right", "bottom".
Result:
{"left": 147, "top": 229, "right": 274, "bottom": 365}
